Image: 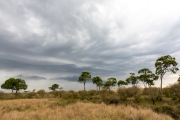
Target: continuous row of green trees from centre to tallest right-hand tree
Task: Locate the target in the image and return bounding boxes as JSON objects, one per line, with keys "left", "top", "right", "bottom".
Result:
{"left": 78, "top": 55, "right": 179, "bottom": 98}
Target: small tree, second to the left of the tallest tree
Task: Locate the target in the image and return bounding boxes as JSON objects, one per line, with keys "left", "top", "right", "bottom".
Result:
{"left": 126, "top": 73, "right": 139, "bottom": 86}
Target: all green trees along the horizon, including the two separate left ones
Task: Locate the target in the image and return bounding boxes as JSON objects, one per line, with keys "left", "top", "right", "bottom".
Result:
{"left": 1, "top": 55, "right": 179, "bottom": 98}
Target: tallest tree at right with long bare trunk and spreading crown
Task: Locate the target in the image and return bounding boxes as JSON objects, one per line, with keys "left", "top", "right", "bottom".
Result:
{"left": 155, "top": 55, "right": 179, "bottom": 99}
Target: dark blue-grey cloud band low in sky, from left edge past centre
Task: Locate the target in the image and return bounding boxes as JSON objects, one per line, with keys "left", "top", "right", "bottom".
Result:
{"left": 0, "top": 59, "right": 113, "bottom": 75}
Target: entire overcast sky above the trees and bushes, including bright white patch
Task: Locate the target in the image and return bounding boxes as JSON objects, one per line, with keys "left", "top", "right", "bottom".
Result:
{"left": 0, "top": 0, "right": 180, "bottom": 91}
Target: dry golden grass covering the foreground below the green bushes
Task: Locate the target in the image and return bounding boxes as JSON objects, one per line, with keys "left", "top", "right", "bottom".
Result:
{"left": 0, "top": 99, "right": 172, "bottom": 120}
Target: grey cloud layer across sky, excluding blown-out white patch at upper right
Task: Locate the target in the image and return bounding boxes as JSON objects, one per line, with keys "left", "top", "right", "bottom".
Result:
{"left": 0, "top": 0, "right": 180, "bottom": 90}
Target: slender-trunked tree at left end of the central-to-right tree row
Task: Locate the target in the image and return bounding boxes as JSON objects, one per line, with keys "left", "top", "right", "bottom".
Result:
{"left": 78, "top": 72, "right": 91, "bottom": 91}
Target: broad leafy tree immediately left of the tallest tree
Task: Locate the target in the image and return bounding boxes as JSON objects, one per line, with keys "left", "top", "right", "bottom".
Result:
{"left": 138, "top": 68, "right": 158, "bottom": 88}
